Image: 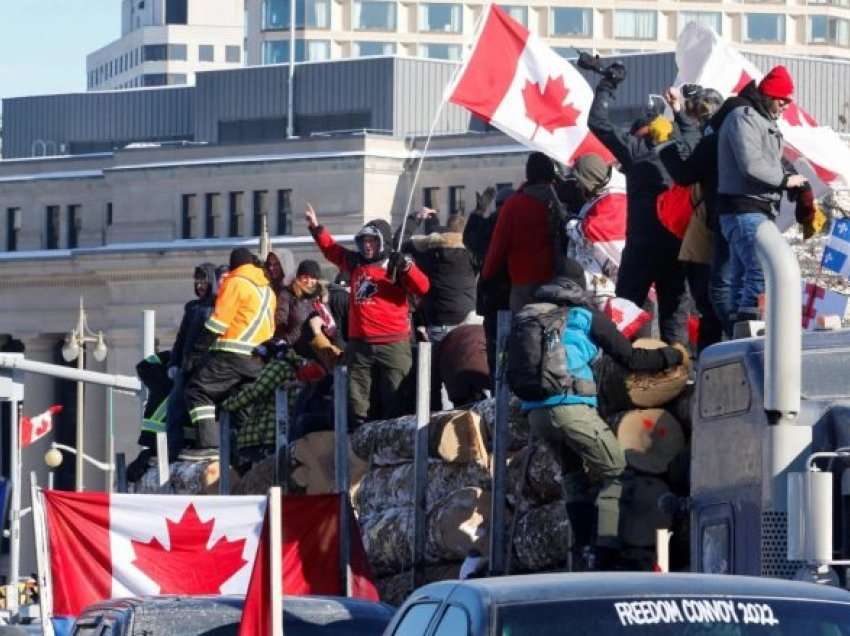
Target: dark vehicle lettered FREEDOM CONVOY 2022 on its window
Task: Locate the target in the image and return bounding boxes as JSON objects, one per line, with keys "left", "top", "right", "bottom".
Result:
{"left": 384, "top": 572, "right": 850, "bottom": 636}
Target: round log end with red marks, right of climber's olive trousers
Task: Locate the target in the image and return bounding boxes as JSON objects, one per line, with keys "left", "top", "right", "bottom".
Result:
{"left": 614, "top": 409, "right": 685, "bottom": 475}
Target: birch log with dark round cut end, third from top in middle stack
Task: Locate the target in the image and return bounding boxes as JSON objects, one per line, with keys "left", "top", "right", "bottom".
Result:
{"left": 360, "top": 488, "right": 490, "bottom": 577}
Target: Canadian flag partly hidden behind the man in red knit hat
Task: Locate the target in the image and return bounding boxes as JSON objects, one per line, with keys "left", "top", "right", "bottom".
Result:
{"left": 676, "top": 22, "right": 850, "bottom": 191}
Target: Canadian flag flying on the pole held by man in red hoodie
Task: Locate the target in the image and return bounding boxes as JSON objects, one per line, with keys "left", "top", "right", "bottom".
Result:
{"left": 449, "top": 3, "right": 613, "bottom": 165}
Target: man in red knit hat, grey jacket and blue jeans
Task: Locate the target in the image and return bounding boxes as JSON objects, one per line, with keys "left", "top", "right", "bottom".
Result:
{"left": 712, "top": 66, "right": 806, "bottom": 324}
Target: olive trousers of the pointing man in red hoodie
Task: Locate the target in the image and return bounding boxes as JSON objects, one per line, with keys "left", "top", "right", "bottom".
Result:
{"left": 345, "top": 339, "right": 413, "bottom": 426}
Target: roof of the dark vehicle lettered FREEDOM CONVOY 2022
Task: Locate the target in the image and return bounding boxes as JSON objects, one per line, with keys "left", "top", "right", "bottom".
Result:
{"left": 411, "top": 572, "right": 850, "bottom": 604}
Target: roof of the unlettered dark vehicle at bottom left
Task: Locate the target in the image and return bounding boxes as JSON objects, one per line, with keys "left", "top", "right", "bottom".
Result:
{"left": 78, "top": 594, "right": 394, "bottom": 620}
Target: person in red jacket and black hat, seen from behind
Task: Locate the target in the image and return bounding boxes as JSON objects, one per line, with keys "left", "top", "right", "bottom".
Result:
{"left": 481, "top": 152, "right": 558, "bottom": 313}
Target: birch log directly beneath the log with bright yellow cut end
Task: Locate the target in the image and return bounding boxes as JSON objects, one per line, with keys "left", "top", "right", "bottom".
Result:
{"left": 352, "top": 461, "right": 490, "bottom": 517}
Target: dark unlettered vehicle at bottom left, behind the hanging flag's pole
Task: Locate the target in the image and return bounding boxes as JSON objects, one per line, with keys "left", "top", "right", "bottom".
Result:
{"left": 71, "top": 596, "right": 393, "bottom": 636}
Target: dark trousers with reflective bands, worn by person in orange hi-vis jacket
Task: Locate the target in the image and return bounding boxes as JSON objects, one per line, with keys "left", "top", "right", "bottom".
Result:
{"left": 184, "top": 351, "right": 263, "bottom": 448}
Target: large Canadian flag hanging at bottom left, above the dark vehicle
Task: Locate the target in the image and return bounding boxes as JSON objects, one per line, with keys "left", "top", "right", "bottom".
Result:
{"left": 43, "top": 490, "right": 267, "bottom": 623}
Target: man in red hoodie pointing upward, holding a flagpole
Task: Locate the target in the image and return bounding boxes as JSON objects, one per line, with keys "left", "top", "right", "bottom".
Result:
{"left": 304, "top": 203, "right": 429, "bottom": 429}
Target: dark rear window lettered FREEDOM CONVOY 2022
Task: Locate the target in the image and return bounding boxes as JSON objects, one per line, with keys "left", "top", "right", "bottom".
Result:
{"left": 496, "top": 597, "right": 850, "bottom": 636}
